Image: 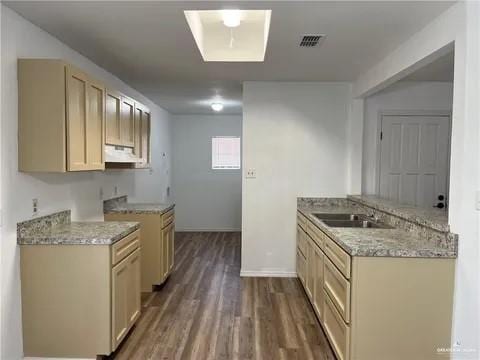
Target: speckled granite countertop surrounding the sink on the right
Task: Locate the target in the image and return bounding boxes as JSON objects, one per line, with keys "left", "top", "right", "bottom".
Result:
{"left": 298, "top": 202, "right": 457, "bottom": 258}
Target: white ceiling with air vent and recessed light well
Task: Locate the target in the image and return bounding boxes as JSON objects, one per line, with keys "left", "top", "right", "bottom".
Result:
{"left": 5, "top": 1, "right": 452, "bottom": 114}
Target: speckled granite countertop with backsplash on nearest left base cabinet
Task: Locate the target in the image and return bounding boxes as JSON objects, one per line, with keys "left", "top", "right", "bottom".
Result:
{"left": 17, "top": 210, "right": 140, "bottom": 245}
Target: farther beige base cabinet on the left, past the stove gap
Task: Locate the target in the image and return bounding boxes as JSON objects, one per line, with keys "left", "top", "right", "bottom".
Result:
{"left": 104, "top": 209, "right": 175, "bottom": 292}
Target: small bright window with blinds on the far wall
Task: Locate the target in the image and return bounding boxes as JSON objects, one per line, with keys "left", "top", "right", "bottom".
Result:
{"left": 212, "top": 136, "right": 240, "bottom": 169}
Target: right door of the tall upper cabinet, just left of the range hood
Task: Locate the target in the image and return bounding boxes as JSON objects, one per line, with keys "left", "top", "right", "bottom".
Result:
{"left": 86, "top": 80, "right": 105, "bottom": 170}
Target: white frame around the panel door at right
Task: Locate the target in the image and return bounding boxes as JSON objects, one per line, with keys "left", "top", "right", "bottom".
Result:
{"left": 375, "top": 110, "right": 452, "bottom": 204}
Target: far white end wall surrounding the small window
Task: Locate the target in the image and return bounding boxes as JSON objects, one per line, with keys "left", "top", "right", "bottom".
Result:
{"left": 172, "top": 115, "right": 242, "bottom": 231}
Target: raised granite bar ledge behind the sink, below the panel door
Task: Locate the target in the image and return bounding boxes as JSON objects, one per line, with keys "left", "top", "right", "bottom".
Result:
{"left": 347, "top": 195, "right": 450, "bottom": 232}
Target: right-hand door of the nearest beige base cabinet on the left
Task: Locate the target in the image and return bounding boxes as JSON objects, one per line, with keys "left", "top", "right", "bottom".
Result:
{"left": 126, "top": 248, "right": 141, "bottom": 327}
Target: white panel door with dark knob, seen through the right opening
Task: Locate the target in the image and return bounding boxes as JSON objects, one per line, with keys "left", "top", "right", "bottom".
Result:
{"left": 380, "top": 115, "right": 450, "bottom": 208}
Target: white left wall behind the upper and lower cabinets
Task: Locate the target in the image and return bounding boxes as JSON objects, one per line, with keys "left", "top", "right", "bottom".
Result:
{"left": 0, "top": 6, "right": 171, "bottom": 360}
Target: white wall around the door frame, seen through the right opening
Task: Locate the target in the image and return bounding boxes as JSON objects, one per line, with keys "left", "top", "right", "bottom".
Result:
{"left": 362, "top": 82, "right": 453, "bottom": 194}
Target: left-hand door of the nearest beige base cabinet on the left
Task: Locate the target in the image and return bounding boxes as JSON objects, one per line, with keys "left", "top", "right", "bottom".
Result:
{"left": 112, "top": 253, "right": 130, "bottom": 350}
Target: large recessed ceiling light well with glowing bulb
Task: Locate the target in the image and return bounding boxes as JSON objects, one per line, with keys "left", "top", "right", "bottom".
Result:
{"left": 184, "top": 9, "right": 272, "bottom": 62}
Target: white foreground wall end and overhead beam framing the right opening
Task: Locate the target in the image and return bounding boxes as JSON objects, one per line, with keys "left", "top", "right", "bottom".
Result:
{"left": 354, "top": 1, "right": 480, "bottom": 359}
